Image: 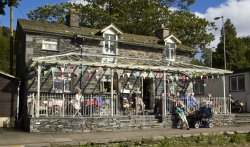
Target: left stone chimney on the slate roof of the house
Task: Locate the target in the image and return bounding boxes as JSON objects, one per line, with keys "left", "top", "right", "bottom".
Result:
{"left": 66, "top": 9, "right": 79, "bottom": 27}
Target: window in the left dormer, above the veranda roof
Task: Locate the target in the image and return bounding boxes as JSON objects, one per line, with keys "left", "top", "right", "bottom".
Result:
{"left": 104, "top": 34, "right": 116, "bottom": 54}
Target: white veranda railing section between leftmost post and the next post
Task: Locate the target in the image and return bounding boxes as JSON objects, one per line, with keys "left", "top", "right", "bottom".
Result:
{"left": 27, "top": 94, "right": 117, "bottom": 117}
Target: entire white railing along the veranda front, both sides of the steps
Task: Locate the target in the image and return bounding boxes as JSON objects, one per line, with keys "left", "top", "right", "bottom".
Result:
{"left": 27, "top": 93, "right": 231, "bottom": 117}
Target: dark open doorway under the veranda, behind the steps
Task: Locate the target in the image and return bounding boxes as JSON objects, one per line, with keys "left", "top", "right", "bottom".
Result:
{"left": 143, "top": 78, "right": 153, "bottom": 109}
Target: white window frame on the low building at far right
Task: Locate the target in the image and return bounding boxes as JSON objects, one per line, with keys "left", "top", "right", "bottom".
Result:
{"left": 229, "top": 74, "right": 246, "bottom": 92}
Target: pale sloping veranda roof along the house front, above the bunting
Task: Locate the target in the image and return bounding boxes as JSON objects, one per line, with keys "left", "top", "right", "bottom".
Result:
{"left": 32, "top": 52, "right": 233, "bottom": 75}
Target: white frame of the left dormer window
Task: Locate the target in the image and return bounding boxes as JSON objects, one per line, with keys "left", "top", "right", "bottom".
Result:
{"left": 103, "top": 30, "right": 118, "bottom": 55}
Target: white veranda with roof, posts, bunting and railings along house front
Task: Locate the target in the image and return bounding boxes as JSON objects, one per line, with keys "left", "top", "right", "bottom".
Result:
{"left": 27, "top": 53, "right": 231, "bottom": 132}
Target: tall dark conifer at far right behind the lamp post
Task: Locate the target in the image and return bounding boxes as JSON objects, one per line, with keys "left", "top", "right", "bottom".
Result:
{"left": 213, "top": 19, "right": 249, "bottom": 71}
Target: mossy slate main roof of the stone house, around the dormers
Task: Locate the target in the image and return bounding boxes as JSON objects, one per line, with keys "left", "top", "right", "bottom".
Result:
{"left": 18, "top": 19, "right": 195, "bottom": 52}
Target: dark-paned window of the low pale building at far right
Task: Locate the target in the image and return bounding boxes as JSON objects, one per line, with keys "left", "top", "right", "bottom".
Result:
{"left": 229, "top": 75, "right": 245, "bottom": 91}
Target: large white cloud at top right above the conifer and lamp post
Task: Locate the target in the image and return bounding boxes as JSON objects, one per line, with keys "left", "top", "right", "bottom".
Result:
{"left": 194, "top": 0, "right": 250, "bottom": 47}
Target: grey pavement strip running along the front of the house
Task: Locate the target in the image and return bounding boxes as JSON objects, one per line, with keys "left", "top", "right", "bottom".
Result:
{"left": 0, "top": 125, "right": 250, "bottom": 147}
